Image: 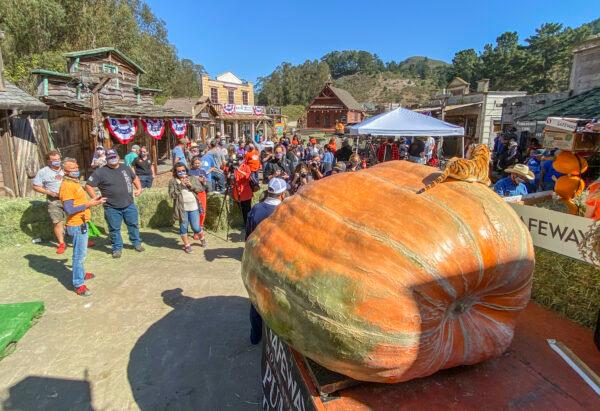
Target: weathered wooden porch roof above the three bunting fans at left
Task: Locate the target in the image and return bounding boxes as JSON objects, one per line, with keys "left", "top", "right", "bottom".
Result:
{"left": 44, "top": 97, "right": 191, "bottom": 118}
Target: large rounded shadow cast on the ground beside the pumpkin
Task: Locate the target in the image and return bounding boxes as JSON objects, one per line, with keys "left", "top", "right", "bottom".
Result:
{"left": 127, "top": 288, "right": 260, "bottom": 410}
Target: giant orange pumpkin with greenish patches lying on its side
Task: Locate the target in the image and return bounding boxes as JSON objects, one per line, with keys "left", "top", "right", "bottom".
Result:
{"left": 242, "top": 161, "right": 534, "bottom": 383}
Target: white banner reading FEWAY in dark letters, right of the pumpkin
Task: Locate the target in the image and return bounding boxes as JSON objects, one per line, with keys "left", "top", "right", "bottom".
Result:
{"left": 510, "top": 204, "right": 594, "bottom": 261}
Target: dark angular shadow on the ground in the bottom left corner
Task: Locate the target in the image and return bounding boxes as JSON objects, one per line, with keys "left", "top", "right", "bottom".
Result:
{"left": 2, "top": 376, "right": 93, "bottom": 411}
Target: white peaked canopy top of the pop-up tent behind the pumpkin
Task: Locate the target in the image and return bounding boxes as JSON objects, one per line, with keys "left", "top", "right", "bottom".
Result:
{"left": 350, "top": 107, "right": 465, "bottom": 137}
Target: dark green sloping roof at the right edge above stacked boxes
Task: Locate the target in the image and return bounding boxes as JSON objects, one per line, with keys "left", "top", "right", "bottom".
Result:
{"left": 515, "top": 87, "right": 600, "bottom": 121}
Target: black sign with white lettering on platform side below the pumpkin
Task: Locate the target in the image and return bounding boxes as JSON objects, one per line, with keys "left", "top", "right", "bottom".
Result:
{"left": 262, "top": 327, "right": 314, "bottom": 411}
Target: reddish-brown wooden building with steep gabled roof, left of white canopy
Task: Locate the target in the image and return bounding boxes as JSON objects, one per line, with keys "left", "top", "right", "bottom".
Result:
{"left": 305, "top": 83, "right": 365, "bottom": 132}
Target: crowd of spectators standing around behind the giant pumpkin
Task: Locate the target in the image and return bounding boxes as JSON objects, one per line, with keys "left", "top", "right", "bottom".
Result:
{"left": 33, "top": 127, "right": 600, "bottom": 300}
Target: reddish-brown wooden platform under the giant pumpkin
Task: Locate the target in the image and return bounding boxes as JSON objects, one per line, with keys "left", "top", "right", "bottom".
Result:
{"left": 263, "top": 303, "right": 600, "bottom": 411}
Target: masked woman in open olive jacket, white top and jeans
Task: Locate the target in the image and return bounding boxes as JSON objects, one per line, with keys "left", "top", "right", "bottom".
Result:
{"left": 169, "top": 163, "right": 206, "bottom": 254}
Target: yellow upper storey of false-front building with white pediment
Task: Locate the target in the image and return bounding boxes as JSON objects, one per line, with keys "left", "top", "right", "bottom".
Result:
{"left": 202, "top": 71, "right": 254, "bottom": 106}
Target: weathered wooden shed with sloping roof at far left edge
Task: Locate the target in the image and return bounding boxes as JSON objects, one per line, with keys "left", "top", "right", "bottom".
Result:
{"left": 0, "top": 32, "right": 51, "bottom": 197}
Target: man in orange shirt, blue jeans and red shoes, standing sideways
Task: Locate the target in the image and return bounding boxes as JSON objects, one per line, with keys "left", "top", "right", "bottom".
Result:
{"left": 58, "top": 158, "right": 106, "bottom": 297}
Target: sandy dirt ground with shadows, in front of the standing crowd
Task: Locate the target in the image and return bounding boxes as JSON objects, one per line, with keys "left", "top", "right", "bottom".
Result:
{"left": 0, "top": 230, "right": 261, "bottom": 410}
